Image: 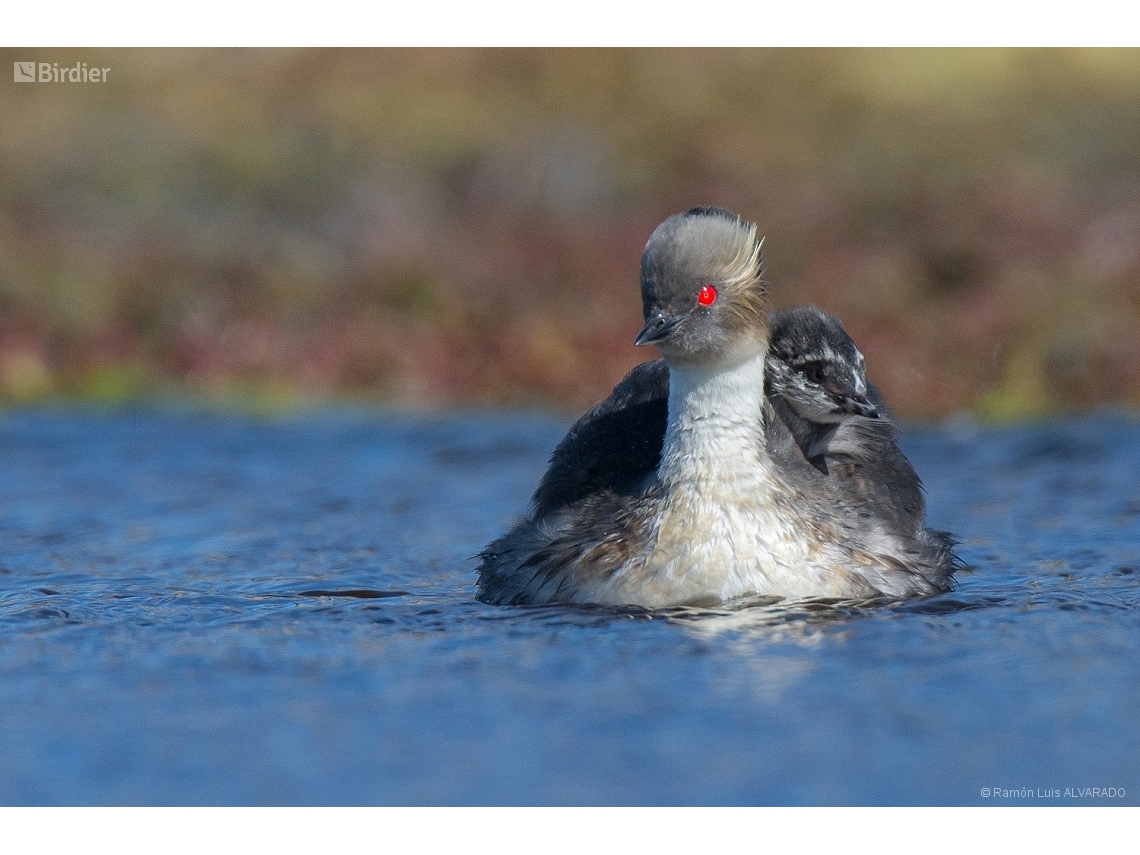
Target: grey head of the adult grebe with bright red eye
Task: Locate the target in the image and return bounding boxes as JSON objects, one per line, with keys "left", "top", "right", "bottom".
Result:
{"left": 635, "top": 207, "right": 767, "bottom": 367}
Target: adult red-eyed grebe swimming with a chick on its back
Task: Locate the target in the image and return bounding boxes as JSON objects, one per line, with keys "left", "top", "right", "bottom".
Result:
{"left": 479, "top": 209, "right": 957, "bottom": 606}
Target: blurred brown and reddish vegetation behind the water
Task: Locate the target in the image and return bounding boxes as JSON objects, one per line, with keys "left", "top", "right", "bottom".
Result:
{"left": 0, "top": 49, "right": 1140, "bottom": 420}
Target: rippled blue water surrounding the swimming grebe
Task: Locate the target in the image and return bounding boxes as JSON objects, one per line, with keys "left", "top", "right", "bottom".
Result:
{"left": 0, "top": 408, "right": 1140, "bottom": 805}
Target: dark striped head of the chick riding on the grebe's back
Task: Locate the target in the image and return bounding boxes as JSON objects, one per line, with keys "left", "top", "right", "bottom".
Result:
{"left": 767, "top": 306, "right": 881, "bottom": 423}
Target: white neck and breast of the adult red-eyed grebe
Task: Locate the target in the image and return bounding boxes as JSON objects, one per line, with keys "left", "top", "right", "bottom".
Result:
{"left": 595, "top": 353, "right": 866, "bottom": 605}
